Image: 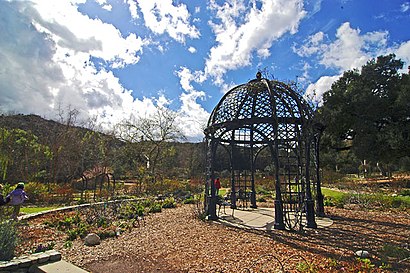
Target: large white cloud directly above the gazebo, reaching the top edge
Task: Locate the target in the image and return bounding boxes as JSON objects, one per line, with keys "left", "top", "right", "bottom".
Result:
{"left": 205, "top": 0, "right": 306, "bottom": 85}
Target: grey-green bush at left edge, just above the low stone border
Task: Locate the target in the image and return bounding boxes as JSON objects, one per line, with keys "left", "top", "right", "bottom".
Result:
{"left": 0, "top": 221, "right": 18, "bottom": 261}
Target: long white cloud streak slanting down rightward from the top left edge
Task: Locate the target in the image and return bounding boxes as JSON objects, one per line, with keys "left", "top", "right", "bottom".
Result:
{"left": 33, "top": 1, "right": 147, "bottom": 67}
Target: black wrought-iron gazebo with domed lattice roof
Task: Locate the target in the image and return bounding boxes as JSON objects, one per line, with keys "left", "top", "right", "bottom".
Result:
{"left": 205, "top": 72, "right": 324, "bottom": 229}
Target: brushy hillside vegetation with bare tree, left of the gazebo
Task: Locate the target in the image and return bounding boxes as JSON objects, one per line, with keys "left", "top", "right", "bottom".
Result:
{"left": 0, "top": 108, "right": 204, "bottom": 204}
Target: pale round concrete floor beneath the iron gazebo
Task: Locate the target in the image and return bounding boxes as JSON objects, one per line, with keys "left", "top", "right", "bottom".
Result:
{"left": 218, "top": 207, "right": 333, "bottom": 231}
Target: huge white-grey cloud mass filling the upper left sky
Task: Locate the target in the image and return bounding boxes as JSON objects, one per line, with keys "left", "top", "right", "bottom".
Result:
{"left": 0, "top": 1, "right": 160, "bottom": 132}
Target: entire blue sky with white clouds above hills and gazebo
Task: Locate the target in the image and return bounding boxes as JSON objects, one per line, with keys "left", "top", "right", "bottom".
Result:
{"left": 0, "top": 0, "right": 410, "bottom": 141}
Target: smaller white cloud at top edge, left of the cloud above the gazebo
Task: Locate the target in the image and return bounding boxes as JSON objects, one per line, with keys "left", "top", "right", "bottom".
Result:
{"left": 136, "top": 0, "right": 200, "bottom": 43}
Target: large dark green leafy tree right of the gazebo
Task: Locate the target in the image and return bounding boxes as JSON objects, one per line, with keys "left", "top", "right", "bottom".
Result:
{"left": 318, "top": 54, "right": 410, "bottom": 174}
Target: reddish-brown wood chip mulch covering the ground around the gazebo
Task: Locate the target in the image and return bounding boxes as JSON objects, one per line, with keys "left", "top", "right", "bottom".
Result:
{"left": 18, "top": 205, "right": 410, "bottom": 273}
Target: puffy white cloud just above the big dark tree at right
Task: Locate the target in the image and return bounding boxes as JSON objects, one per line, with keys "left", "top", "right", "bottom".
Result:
{"left": 294, "top": 22, "right": 410, "bottom": 103}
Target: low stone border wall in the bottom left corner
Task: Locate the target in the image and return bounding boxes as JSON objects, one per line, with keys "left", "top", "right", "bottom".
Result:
{"left": 0, "top": 250, "right": 61, "bottom": 273}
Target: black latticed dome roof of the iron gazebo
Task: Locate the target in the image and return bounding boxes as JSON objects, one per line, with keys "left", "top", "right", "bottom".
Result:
{"left": 205, "top": 78, "right": 311, "bottom": 143}
